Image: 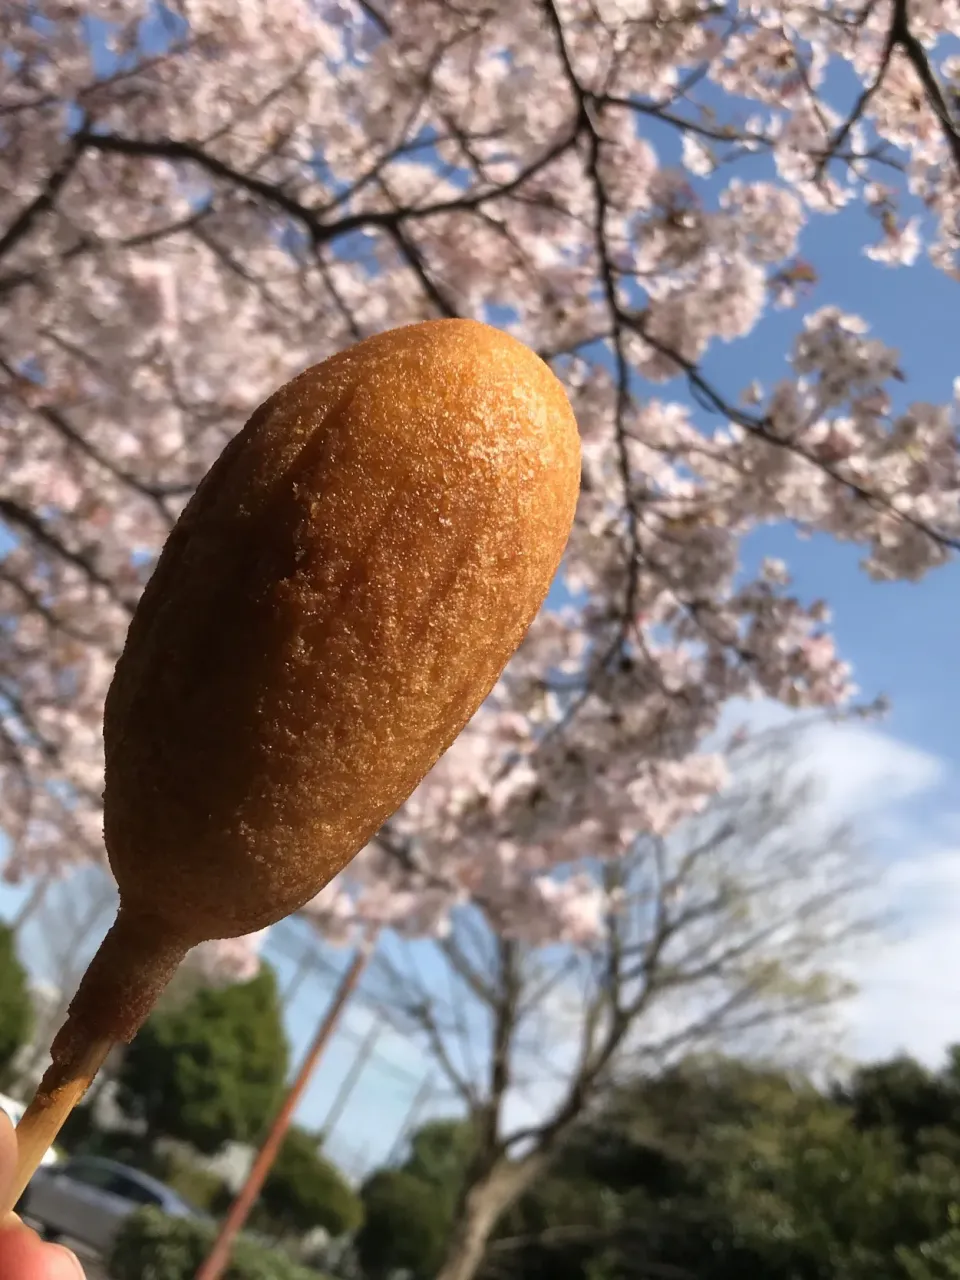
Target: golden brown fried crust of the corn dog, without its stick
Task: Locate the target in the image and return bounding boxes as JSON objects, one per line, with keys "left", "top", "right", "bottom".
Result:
{"left": 105, "top": 320, "right": 580, "bottom": 942}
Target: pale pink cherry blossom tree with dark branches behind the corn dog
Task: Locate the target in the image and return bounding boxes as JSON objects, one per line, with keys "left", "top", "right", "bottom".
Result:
{"left": 0, "top": 0, "right": 960, "bottom": 1259}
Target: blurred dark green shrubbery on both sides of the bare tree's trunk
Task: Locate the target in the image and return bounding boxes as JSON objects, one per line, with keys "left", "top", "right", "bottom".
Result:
{"left": 357, "top": 1055, "right": 960, "bottom": 1280}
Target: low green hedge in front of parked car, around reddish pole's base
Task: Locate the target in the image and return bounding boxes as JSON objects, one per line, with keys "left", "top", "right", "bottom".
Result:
{"left": 109, "top": 1208, "right": 324, "bottom": 1280}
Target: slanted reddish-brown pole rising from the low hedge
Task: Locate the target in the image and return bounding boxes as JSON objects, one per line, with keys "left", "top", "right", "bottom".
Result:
{"left": 196, "top": 932, "right": 376, "bottom": 1280}
